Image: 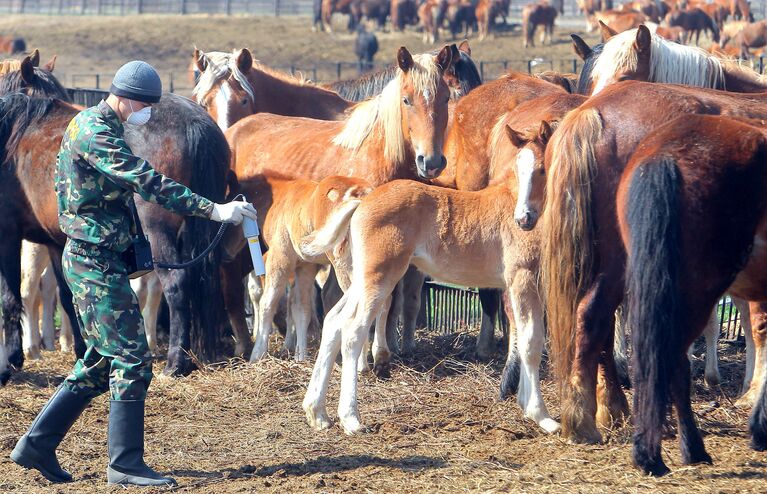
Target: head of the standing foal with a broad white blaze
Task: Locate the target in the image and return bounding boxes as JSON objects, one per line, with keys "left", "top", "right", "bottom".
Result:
{"left": 505, "top": 120, "right": 552, "bottom": 231}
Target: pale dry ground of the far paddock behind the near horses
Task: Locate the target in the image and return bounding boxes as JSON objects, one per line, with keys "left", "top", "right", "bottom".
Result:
{"left": 0, "top": 15, "right": 608, "bottom": 89}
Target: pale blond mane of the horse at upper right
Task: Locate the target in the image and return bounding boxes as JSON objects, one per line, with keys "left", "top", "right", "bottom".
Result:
{"left": 591, "top": 29, "right": 724, "bottom": 93}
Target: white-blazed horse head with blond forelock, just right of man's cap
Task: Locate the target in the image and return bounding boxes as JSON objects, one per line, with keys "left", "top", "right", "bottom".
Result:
{"left": 193, "top": 48, "right": 256, "bottom": 131}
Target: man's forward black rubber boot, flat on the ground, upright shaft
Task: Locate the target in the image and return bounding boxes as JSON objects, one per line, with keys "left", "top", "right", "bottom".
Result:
{"left": 107, "top": 400, "right": 176, "bottom": 486}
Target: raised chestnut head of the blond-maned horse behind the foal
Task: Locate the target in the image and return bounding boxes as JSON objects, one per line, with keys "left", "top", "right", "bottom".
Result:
{"left": 400, "top": 45, "right": 453, "bottom": 178}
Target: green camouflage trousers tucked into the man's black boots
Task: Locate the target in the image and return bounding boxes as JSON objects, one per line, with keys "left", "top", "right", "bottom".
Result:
{"left": 62, "top": 240, "right": 152, "bottom": 400}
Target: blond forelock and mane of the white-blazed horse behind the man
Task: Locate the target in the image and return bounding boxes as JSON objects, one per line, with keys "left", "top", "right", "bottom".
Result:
{"left": 192, "top": 50, "right": 311, "bottom": 103}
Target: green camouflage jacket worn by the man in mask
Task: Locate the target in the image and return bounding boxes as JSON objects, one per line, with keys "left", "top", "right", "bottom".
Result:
{"left": 56, "top": 100, "right": 213, "bottom": 252}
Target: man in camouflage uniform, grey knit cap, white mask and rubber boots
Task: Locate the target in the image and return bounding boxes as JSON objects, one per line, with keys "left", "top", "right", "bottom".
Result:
{"left": 11, "top": 61, "right": 256, "bottom": 485}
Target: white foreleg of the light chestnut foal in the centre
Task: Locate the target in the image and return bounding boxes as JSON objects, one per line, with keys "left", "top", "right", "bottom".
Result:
{"left": 509, "top": 270, "right": 559, "bottom": 433}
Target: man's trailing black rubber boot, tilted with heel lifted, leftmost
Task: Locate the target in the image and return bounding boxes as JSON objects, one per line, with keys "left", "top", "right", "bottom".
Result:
{"left": 11, "top": 384, "right": 90, "bottom": 482}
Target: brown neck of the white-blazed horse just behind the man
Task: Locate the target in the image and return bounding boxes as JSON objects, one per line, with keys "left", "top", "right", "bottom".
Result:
{"left": 248, "top": 67, "right": 350, "bottom": 120}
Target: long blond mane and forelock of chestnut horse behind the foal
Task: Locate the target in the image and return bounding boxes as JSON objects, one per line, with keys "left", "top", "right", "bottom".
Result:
{"left": 333, "top": 54, "right": 442, "bottom": 162}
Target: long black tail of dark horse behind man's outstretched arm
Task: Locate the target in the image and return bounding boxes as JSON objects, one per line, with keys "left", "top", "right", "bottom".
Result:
{"left": 178, "top": 103, "right": 229, "bottom": 361}
